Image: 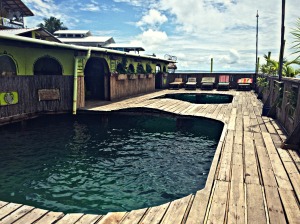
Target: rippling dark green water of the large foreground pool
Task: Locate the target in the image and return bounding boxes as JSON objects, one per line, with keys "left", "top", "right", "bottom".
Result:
{"left": 0, "top": 114, "right": 223, "bottom": 214}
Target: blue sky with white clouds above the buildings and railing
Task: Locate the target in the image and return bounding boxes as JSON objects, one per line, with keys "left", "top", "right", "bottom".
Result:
{"left": 23, "top": 0, "right": 300, "bottom": 71}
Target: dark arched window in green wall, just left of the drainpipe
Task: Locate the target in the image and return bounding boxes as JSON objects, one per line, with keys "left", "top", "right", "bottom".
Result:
{"left": 33, "top": 56, "right": 62, "bottom": 75}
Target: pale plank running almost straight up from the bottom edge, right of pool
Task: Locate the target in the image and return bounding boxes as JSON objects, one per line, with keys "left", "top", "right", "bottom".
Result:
{"left": 227, "top": 181, "right": 245, "bottom": 223}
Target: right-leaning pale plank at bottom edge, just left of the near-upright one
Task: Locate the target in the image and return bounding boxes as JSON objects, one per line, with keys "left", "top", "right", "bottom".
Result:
{"left": 207, "top": 180, "right": 229, "bottom": 223}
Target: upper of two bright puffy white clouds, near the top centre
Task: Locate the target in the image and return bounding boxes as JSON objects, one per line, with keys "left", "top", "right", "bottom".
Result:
{"left": 137, "top": 9, "right": 168, "bottom": 27}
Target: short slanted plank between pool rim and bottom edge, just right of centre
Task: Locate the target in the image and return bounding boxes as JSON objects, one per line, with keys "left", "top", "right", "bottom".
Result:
{"left": 161, "top": 195, "right": 192, "bottom": 224}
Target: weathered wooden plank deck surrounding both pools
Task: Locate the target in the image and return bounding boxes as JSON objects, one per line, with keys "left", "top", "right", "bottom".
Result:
{"left": 0, "top": 90, "right": 300, "bottom": 224}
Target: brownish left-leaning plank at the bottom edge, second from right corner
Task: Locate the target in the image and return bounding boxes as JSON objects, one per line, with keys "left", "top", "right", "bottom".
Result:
{"left": 265, "top": 186, "right": 287, "bottom": 224}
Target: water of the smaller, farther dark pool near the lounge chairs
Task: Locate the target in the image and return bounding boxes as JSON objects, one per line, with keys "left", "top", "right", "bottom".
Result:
{"left": 157, "top": 93, "right": 233, "bottom": 104}
